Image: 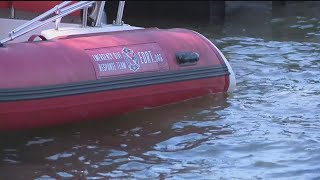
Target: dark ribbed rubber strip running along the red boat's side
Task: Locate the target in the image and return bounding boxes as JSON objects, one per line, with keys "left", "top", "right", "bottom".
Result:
{"left": 0, "top": 65, "right": 229, "bottom": 102}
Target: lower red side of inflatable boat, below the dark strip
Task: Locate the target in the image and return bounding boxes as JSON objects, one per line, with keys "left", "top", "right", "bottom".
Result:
{"left": 0, "top": 77, "right": 228, "bottom": 131}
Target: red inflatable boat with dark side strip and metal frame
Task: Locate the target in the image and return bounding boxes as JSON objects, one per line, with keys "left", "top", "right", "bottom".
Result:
{"left": 0, "top": 1, "right": 235, "bottom": 131}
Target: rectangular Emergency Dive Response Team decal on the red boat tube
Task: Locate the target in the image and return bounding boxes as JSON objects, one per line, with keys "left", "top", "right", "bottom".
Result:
{"left": 86, "top": 43, "right": 169, "bottom": 78}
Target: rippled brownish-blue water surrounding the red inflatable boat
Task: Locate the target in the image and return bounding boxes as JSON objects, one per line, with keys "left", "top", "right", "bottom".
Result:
{"left": 0, "top": 2, "right": 320, "bottom": 179}
